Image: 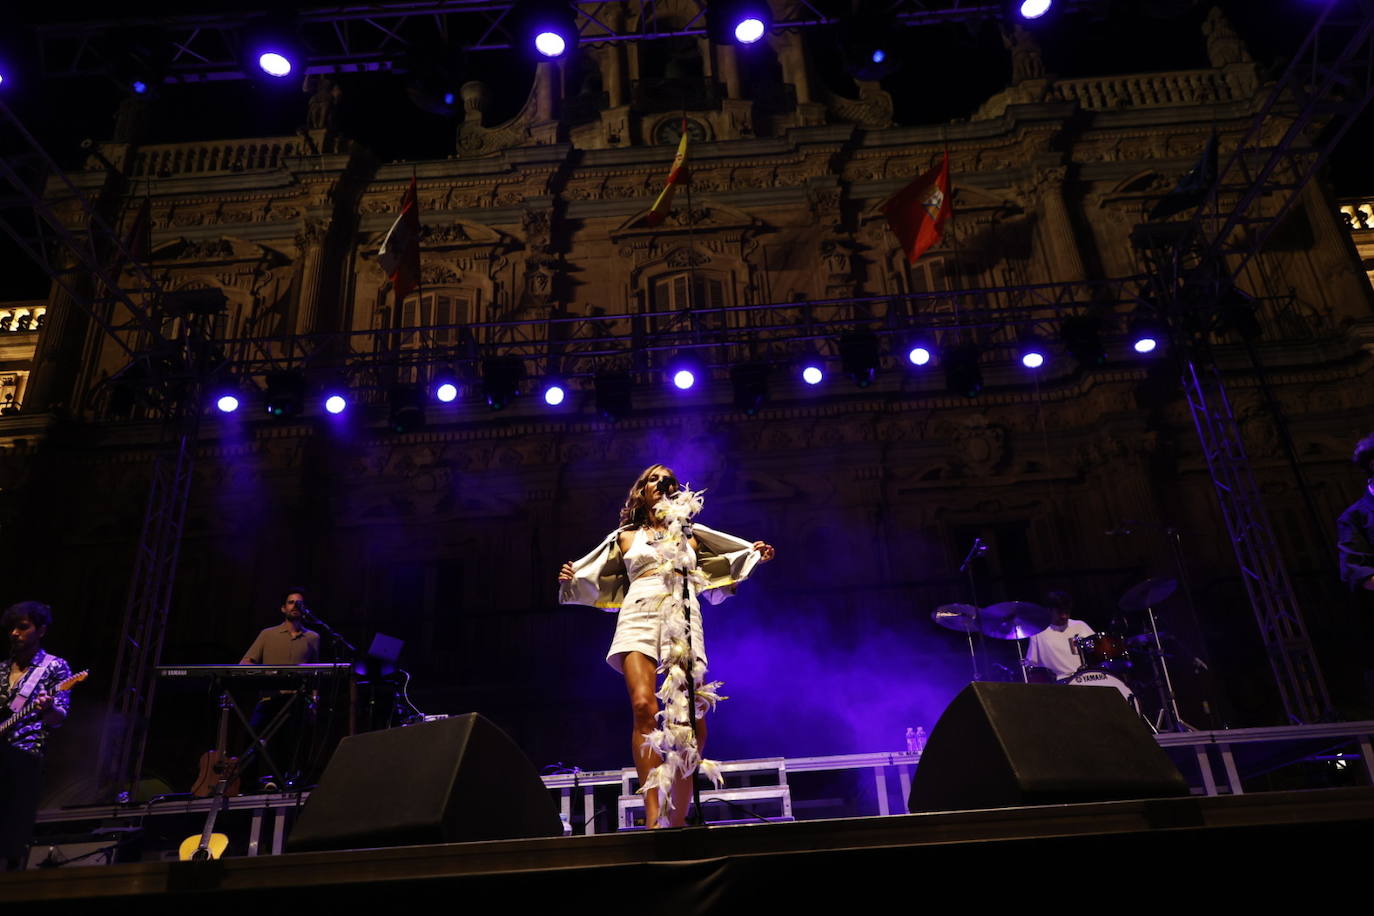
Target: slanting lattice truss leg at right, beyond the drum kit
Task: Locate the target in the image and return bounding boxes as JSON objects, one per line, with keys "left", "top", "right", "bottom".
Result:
{"left": 1183, "top": 361, "right": 1331, "bottom": 724}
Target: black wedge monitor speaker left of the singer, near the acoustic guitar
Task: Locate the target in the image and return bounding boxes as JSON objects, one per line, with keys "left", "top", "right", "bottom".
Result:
{"left": 286, "top": 713, "right": 563, "bottom": 853}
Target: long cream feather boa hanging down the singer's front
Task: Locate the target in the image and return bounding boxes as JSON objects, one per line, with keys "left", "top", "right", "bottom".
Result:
{"left": 639, "top": 488, "right": 727, "bottom": 825}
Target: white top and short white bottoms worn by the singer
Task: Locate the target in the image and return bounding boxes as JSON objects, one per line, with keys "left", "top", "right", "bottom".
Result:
{"left": 606, "top": 529, "right": 706, "bottom": 672}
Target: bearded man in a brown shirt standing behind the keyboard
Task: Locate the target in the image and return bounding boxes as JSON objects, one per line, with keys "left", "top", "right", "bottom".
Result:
{"left": 239, "top": 588, "right": 320, "bottom": 791}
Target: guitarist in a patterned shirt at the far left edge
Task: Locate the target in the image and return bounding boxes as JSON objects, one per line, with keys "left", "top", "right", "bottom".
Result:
{"left": 0, "top": 602, "right": 71, "bottom": 871}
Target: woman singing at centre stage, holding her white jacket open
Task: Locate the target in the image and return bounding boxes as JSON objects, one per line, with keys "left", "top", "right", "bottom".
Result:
{"left": 558, "top": 464, "right": 774, "bottom": 828}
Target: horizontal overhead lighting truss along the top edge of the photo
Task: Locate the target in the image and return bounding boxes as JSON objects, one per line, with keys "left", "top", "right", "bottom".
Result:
{"left": 38, "top": 0, "right": 1105, "bottom": 82}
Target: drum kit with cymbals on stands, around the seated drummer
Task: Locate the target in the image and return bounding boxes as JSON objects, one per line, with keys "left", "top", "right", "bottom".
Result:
{"left": 930, "top": 578, "right": 1187, "bottom": 731}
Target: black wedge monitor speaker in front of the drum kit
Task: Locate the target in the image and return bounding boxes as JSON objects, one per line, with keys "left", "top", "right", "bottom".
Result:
{"left": 907, "top": 681, "right": 1189, "bottom": 812}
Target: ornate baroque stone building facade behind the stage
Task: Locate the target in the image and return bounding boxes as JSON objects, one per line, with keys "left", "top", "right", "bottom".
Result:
{"left": 8, "top": 4, "right": 1374, "bottom": 791}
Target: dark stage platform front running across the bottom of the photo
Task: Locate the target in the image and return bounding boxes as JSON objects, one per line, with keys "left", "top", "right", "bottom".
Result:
{"left": 0, "top": 787, "right": 1374, "bottom": 913}
